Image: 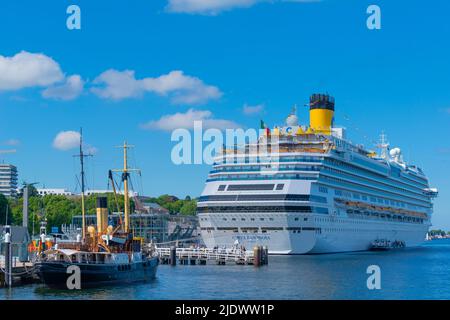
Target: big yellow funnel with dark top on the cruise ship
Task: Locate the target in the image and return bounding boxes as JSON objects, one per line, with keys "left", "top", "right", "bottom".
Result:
{"left": 309, "top": 93, "right": 334, "bottom": 134}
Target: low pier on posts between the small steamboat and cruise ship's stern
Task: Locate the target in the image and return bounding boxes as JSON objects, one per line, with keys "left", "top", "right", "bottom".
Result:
{"left": 156, "top": 246, "right": 268, "bottom": 266}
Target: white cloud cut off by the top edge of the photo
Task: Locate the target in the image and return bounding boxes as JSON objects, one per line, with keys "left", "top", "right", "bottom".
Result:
{"left": 166, "top": 0, "right": 320, "bottom": 15}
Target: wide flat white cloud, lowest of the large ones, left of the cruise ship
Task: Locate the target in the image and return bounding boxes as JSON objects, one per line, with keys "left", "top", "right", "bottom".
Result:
{"left": 141, "top": 109, "right": 241, "bottom": 131}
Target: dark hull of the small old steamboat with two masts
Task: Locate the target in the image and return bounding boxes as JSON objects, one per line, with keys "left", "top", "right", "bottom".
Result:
{"left": 36, "top": 257, "right": 159, "bottom": 289}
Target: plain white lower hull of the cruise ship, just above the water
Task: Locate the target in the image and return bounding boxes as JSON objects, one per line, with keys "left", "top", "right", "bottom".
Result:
{"left": 202, "top": 212, "right": 428, "bottom": 255}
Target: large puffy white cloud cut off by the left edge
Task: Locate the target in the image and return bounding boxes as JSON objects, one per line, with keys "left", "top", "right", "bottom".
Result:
{"left": 0, "top": 51, "right": 64, "bottom": 90}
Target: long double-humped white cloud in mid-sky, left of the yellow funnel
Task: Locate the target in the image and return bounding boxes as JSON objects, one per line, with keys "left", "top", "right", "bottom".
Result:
{"left": 91, "top": 69, "right": 222, "bottom": 104}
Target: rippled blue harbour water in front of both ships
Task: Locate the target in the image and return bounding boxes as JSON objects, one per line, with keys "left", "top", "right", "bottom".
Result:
{"left": 0, "top": 239, "right": 450, "bottom": 300}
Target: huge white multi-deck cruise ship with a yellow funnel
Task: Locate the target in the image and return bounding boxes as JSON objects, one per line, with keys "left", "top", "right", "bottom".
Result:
{"left": 197, "top": 94, "right": 438, "bottom": 254}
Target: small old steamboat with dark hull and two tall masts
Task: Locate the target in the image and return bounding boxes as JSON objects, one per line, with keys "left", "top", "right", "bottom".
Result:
{"left": 35, "top": 131, "right": 159, "bottom": 289}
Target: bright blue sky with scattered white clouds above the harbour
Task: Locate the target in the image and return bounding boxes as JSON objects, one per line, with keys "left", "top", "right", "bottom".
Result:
{"left": 0, "top": 0, "right": 450, "bottom": 229}
